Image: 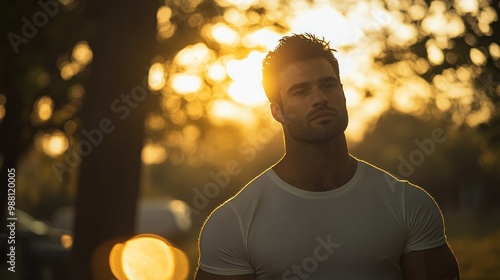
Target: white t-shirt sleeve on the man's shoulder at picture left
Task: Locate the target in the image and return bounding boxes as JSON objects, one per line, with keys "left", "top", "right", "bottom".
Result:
{"left": 199, "top": 204, "right": 254, "bottom": 275}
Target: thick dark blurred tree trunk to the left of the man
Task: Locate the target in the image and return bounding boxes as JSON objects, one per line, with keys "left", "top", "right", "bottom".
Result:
{"left": 73, "top": 0, "right": 157, "bottom": 280}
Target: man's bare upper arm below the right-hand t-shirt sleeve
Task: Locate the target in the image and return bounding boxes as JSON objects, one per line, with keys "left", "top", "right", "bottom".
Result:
{"left": 401, "top": 243, "right": 460, "bottom": 280}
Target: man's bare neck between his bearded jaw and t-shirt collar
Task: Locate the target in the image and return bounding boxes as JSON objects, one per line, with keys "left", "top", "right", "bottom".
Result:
{"left": 273, "top": 135, "right": 357, "bottom": 191}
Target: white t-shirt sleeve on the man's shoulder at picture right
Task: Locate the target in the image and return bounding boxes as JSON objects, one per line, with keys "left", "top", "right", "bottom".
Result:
{"left": 403, "top": 184, "right": 446, "bottom": 254}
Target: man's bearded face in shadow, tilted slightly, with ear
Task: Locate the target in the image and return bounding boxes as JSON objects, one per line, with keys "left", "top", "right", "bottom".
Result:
{"left": 271, "top": 58, "right": 348, "bottom": 143}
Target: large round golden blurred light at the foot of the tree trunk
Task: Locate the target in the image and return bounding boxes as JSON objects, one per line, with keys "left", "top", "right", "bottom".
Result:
{"left": 109, "top": 234, "right": 189, "bottom": 280}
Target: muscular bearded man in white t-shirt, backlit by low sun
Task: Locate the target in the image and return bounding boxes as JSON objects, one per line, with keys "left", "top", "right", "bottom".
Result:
{"left": 196, "top": 34, "right": 459, "bottom": 280}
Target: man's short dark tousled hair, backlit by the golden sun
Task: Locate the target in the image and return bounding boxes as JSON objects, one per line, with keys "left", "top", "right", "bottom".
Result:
{"left": 262, "top": 33, "right": 340, "bottom": 104}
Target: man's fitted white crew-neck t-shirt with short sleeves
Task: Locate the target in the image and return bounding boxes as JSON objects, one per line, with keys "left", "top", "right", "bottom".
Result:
{"left": 199, "top": 160, "right": 445, "bottom": 280}
